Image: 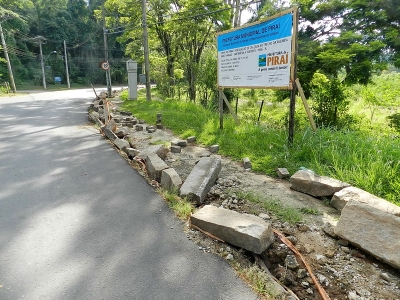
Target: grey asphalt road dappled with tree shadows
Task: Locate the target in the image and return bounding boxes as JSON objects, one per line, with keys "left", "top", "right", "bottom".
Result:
{"left": 0, "top": 89, "right": 257, "bottom": 300}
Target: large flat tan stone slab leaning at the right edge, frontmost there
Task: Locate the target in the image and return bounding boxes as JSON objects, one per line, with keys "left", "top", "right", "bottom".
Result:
{"left": 335, "top": 200, "right": 400, "bottom": 269}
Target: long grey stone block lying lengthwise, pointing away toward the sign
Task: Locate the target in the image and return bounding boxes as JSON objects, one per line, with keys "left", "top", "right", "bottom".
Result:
{"left": 180, "top": 157, "right": 222, "bottom": 204}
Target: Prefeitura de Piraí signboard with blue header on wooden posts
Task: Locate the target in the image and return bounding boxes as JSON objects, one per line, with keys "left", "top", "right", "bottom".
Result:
{"left": 217, "top": 7, "right": 315, "bottom": 144}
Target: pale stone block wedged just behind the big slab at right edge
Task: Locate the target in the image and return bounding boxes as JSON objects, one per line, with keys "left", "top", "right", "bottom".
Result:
{"left": 331, "top": 186, "right": 400, "bottom": 217}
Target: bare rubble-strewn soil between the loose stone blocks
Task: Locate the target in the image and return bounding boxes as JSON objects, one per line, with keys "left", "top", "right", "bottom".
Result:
{"left": 95, "top": 102, "right": 400, "bottom": 300}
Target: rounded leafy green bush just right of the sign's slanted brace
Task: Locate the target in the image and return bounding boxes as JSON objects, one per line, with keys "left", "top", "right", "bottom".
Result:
{"left": 311, "top": 72, "right": 349, "bottom": 128}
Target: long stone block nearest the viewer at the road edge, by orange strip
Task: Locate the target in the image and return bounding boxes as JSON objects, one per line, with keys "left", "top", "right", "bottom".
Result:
{"left": 190, "top": 205, "right": 274, "bottom": 254}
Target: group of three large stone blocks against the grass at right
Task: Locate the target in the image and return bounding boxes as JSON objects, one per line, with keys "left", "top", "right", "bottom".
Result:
{"left": 290, "top": 170, "right": 400, "bottom": 269}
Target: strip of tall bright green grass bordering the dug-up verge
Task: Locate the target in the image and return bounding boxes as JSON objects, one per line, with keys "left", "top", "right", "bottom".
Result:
{"left": 120, "top": 89, "right": 400, "bottom": 206}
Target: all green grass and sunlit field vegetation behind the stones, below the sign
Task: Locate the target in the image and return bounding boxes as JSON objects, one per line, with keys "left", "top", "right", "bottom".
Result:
{"left": 121, "top": 72, "right": 400, "bottom": 205}
